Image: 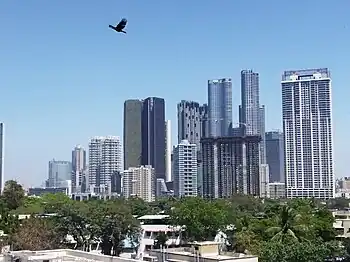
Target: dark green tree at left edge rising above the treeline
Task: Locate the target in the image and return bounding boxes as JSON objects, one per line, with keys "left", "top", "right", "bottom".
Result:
{"left": 2, "top": 180, "right": 24, "bottom": 210}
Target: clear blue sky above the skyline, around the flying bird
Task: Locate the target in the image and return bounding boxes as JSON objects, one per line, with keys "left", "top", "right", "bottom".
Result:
{"left": 0, "top": 0, "right": 350, "bottom": 185}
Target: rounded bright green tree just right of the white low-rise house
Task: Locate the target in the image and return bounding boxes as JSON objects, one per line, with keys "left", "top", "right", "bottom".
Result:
{"left": 170, "top": 197, "right": 229, "bottom": 241}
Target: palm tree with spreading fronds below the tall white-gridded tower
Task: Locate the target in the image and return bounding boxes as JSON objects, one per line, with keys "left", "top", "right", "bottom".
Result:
{"left": 267, "top": 205, "right": 307, "bottom": 243}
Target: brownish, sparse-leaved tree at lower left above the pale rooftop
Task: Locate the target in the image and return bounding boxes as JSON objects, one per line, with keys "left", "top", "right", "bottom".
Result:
{"left": 13, "top": 217, "right": 65, "bottom": 251}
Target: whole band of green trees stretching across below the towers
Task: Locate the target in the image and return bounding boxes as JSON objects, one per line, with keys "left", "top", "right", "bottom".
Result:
{"left": 4, "top": 178, "right": 344, "bottom": 262}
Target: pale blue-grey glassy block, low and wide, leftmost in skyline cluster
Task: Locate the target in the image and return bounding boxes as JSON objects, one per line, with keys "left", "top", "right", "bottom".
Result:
{"left": 48, "top": 159, "right": 72, "bottom": 187}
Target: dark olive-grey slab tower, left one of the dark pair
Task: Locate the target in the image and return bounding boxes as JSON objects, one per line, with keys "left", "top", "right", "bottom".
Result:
{"left": 123, "top": 99, "right": 143, "bottom": 169}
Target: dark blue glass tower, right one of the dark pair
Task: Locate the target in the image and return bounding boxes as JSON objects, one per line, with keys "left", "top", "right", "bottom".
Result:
{"left": 141, "top": 97, "right": 165, "bottom": 180}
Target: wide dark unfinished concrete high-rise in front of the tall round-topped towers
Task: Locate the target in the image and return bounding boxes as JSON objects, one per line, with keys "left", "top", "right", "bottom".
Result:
{"left": 201, "top": 135, "right": 261, "bottom": 198}
